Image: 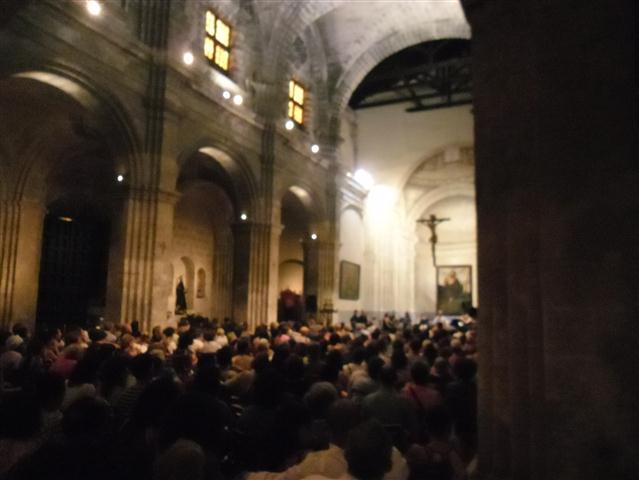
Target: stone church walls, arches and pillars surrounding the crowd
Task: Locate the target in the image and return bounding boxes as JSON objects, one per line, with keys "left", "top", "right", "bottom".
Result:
{"left": 0, "top": 0, "right": 639, "bottom": 480}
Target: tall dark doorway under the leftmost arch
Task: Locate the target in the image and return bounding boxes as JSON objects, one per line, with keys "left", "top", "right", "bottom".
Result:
{"left": 37, "top": 211, "right": 109, "bottom": 326}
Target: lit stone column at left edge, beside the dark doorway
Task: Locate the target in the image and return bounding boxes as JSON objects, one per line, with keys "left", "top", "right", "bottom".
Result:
{"left": 0, "top": 199, "right": 45, "bottom": 327}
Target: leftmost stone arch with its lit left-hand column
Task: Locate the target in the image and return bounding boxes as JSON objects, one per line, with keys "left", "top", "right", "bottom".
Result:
{"left": 0, "top": 64, "right": 141, "bottom": 323}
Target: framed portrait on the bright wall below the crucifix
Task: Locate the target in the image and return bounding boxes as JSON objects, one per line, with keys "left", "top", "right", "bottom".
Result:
{"left": 437, "top": 265, "right": 473, "bottom": 315}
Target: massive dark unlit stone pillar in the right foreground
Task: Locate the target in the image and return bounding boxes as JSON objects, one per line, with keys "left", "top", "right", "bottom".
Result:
{"left": 464, "top": 0, "right": 639, "bottom": 480}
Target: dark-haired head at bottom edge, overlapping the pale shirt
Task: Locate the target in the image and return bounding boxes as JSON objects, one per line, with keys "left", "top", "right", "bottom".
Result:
{"left": 344, "top": 420, "right": 393, "bottom": 480}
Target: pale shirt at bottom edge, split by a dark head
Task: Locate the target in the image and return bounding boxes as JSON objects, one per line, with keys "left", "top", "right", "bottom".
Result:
{"left": 246, "top": 444, "right": 408, "bottom": 480}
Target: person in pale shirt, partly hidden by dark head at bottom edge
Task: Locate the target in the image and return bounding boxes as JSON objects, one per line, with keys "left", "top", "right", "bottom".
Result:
{"left": 247, "top": 400, "right": 408, "bottom": 480}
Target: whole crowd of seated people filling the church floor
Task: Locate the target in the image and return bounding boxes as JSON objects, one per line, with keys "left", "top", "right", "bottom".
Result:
{"left": 0, "top": 317, "right": 477, "bottom": 480}
